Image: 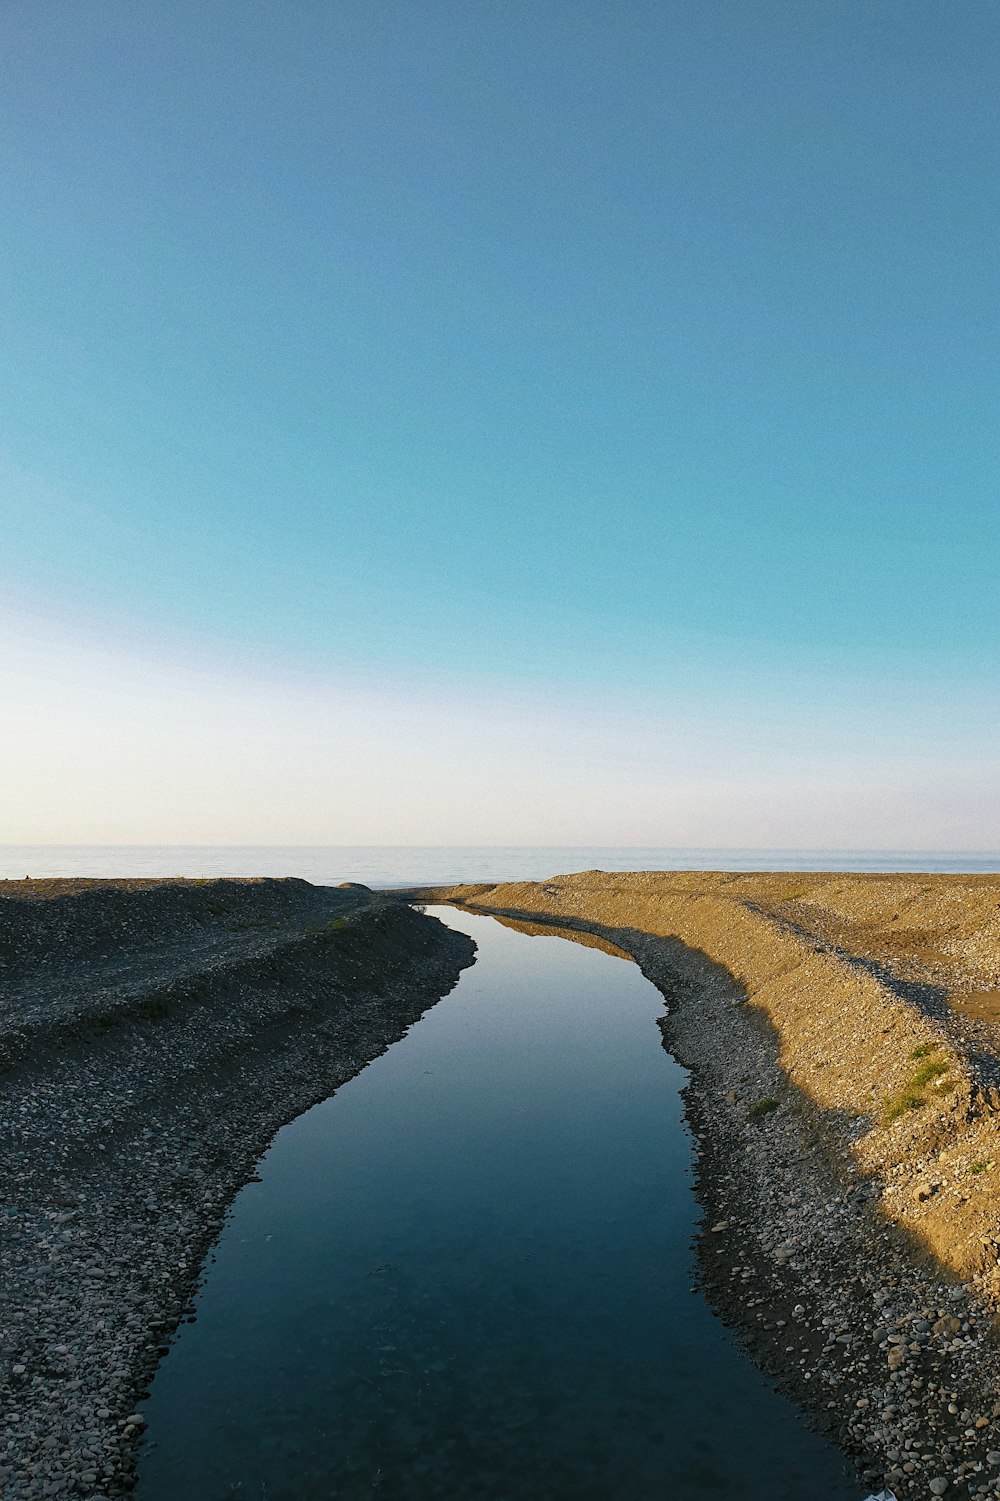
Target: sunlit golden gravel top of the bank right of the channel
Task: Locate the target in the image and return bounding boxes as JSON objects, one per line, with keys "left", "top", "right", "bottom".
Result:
{"left": 411, "top": 871, "right": 1000, "bottom": 1297}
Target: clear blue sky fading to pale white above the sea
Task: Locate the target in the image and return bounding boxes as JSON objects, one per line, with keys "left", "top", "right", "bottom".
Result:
{"left": 0, "top": 0, "right": 1000, "bottom": 850}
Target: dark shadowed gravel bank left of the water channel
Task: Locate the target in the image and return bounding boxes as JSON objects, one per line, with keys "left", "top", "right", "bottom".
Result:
{"left": 0, "top": 881, "right": 473, "bottom": 1501}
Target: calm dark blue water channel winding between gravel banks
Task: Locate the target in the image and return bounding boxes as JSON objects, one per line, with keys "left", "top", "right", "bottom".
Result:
{"left": 138, "top": 910, "right": 862, "bottom": 1501}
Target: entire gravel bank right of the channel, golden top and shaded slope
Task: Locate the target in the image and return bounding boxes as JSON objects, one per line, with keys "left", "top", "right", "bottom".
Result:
{"left": 402, "top": 872, "right": 1000, "bottom": 1498}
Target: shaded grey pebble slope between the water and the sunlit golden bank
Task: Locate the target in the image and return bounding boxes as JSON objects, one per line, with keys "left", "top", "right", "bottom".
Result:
{"left": 659, "top": 924, "right": 1000, "bottom": 1496}
